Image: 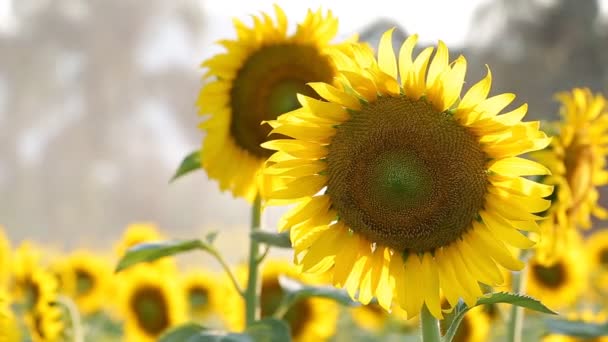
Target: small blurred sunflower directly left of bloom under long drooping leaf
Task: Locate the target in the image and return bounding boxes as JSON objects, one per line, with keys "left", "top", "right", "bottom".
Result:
{"left": 60, "top": 250, "right": 112, "bottom": 315}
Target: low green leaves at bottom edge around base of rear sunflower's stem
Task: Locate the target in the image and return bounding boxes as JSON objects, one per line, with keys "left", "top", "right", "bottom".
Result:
{"left": 160, "top": 318, "right": 291, "bottom": 342}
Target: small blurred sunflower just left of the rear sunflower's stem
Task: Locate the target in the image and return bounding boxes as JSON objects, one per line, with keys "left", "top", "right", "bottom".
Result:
{"left": 182, "top": 270, "right": 222, "bottom": 319}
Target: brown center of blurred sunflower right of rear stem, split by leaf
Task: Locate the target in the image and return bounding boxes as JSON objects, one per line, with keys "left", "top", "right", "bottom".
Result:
{"left": 260, "top": 278, "right": 312, "bottom": 338}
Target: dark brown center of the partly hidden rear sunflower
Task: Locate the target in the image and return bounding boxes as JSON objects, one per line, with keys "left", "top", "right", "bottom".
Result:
{"left": 230, "top": 43, "right": 335, "bottom": 158}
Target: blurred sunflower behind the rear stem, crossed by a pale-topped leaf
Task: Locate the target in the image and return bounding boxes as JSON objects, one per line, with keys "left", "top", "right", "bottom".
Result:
{"left": 226, "top": 260, "right": 338, "bottom": 342}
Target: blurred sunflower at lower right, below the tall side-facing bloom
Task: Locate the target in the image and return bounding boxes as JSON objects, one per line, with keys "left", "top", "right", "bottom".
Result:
{"left": 526, "top": 248, "right": 587, "bottom": 309}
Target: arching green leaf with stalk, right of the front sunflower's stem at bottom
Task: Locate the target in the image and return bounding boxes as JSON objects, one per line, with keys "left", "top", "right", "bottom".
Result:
{"left": 443, "top": 292, "right": 557, "bottom": 342}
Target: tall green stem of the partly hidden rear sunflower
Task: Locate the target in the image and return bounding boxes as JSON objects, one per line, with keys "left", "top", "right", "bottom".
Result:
{"left": 245, "top": 194, "right": 262, "bottom": 326}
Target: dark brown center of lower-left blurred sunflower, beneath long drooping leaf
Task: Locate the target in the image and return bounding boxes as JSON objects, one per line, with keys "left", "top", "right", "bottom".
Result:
{"left": 131, "top": 287, "right": 170, "bottom": 336}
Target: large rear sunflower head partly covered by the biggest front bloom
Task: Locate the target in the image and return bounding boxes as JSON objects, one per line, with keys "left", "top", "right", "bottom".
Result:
{"left": 197, "top": 6, "right": 346, "bottom": 201}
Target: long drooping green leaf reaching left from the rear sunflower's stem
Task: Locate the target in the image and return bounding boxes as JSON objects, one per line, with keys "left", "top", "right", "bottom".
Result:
{"left": 115, "top": 240, "right": 209, "bottom": 272}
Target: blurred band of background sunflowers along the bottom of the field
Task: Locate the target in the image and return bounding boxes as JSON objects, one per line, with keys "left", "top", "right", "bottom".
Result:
{"left": 0, "top": 224, "right": 608, "bottom": 342}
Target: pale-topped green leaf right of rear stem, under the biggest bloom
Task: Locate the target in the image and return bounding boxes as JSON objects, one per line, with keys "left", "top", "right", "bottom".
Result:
{"left": 279, "top": 276, "right": 360, "bottom": 306}
